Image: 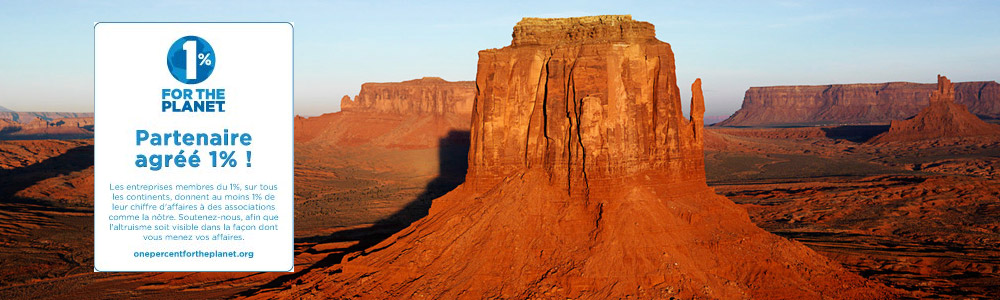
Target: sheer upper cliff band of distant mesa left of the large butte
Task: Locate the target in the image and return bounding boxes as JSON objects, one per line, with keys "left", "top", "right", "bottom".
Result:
{"left": 340, "top": 77, "right": 476, "bottom": 115}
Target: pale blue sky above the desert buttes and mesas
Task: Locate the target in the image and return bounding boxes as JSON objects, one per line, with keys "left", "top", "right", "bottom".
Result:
{"left": 0, "top": 0, "right": 1000, "bottom": 115}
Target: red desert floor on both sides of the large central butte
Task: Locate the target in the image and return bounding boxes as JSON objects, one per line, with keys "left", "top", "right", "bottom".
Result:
{"left": 0, "top": 101, "right": 1000, "bottom": 299}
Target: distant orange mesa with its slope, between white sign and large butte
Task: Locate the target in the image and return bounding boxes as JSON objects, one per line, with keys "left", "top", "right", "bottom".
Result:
{"left": 295, "top": 77, "right": 476, "bottom": 149}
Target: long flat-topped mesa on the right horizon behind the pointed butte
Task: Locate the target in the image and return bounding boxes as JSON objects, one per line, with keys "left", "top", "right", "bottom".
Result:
{"left": 716, "top": 81, "right": 1000, "bottom": 126}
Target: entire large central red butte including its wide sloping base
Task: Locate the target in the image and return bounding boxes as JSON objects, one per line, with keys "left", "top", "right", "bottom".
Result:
{"left": 255, "top": 16, "right": 893, "bottom": 299}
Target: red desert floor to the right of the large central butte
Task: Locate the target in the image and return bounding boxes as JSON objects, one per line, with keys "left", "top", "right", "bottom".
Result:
{"left": 705, "top": 103, "right": 1000, "bottom": 299}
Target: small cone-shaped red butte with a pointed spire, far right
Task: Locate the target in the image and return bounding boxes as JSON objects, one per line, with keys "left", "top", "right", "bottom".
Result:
{"left": 868, "top": 75, "right": 1000, "bottom": 144}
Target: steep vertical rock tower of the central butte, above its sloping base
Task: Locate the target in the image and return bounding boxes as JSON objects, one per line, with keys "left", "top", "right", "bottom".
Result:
{"left": 469, "top": 16, "right": 705, "bottom": 194}
